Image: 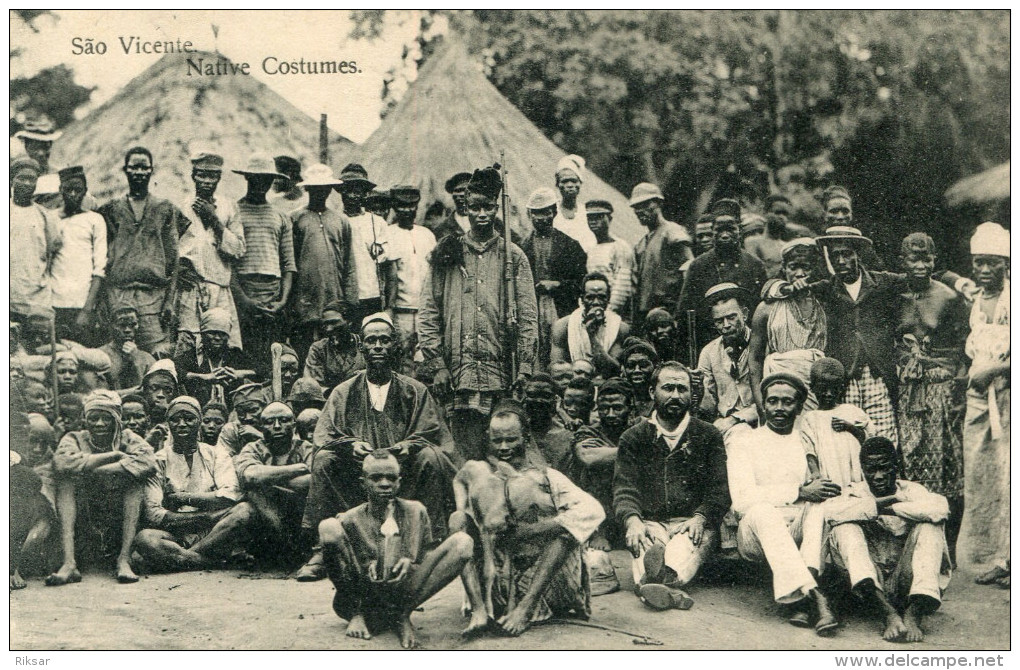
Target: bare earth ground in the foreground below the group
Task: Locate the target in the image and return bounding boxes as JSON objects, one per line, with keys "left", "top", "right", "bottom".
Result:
{"left": 10, "top": 552, "right": 1010, "bottom": 651}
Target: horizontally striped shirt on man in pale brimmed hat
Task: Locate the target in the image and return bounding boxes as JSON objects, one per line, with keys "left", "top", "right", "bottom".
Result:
{"left": 227, "top": 200, "right": 298, "bottom": 277}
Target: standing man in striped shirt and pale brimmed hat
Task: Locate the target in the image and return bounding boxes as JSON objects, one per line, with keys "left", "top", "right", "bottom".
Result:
{"left": 232, "top": 153, "right": 298, "bottom": 379}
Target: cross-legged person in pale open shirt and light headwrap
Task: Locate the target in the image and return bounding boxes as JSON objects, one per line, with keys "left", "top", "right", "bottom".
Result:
{"left": 135, "top": 396, "right": 255, "bottom": 572}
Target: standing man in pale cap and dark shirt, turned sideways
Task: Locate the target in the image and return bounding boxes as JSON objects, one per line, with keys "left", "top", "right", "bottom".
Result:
{"left": 630, "top": 183, "right": 693, "bottom": 329}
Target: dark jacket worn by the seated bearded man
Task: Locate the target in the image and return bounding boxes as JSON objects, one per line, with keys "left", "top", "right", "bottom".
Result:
{"left": 613, "top": 417, "right": 729, "bottom": 527}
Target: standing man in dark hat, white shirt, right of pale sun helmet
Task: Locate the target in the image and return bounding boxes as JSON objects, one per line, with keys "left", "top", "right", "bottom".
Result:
{"left": 340, "top": 163, "right": 398, "bottom": 323}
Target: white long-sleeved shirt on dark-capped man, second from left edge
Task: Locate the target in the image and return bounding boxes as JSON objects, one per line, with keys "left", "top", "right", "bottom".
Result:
{"left": 50, "top": 212, "right": 106, "bottom": 309}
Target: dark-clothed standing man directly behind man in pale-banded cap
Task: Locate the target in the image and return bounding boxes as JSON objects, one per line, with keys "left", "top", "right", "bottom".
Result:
{"left": 675, "top": 199, "right": 766, "bottom": 351}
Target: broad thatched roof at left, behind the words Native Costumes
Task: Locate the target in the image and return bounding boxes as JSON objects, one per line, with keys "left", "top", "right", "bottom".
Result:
{"left": 50, "top": 52, "right": 351, "bottom": 204}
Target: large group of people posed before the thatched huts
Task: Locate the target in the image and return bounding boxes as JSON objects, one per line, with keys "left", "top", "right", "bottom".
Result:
{"left": 10, "top": 121, "right": 1010, "bottom": 647}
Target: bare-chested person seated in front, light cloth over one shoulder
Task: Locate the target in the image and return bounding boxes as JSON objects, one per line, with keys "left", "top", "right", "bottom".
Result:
{"left": 450, "top": 400, "right": 606, "bottom": 635}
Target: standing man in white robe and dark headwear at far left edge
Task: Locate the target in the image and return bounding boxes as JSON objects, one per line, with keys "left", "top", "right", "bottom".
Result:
{"left": 9, "top": 156, "right": 63, "bottom": 321}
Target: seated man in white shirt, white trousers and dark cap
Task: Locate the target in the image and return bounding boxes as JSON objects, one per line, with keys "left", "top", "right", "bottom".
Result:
{"left": 726, "top": 372, "right": 839, "bottom": 636}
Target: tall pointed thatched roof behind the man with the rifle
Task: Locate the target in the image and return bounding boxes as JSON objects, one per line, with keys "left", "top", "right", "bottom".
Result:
{"left": 342, "top": 37, "right": 645, "bottom": 244}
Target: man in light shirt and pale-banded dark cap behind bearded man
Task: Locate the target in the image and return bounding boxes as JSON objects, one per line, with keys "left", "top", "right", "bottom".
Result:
{"left": 698, "top": 284, "right": 758, "bottom": 444}
